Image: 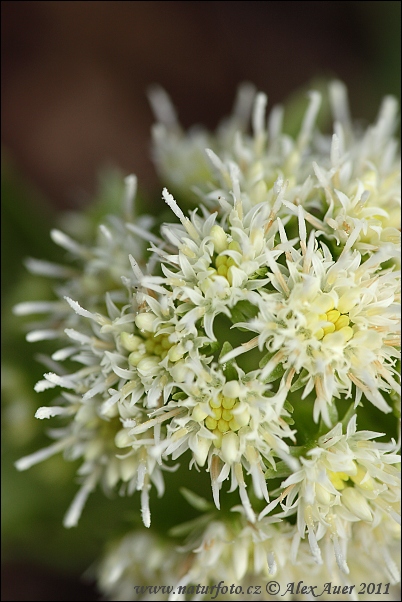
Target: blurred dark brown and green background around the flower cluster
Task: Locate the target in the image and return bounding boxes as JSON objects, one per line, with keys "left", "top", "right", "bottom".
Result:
{"left": 1, "top": 1, "right": 401, "bottom": 600}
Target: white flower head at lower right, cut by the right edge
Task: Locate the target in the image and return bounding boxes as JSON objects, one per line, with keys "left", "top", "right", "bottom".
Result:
{"left": 272, "top": 415, "right": 400, "bottom": 573}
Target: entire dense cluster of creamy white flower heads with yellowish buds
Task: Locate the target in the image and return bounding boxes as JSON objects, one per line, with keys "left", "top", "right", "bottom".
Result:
{"left": 16, "top": 82, "right": 400, "bottom": 599}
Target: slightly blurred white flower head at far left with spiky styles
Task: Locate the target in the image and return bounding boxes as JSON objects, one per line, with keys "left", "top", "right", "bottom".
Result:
{"left": 16, "top": 280, "right": 170, "bottom": 527}
